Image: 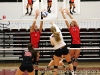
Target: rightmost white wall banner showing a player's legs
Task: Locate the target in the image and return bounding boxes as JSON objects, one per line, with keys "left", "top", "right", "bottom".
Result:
{"left": 63, "top": 0, "right": 80, "bottom": 15}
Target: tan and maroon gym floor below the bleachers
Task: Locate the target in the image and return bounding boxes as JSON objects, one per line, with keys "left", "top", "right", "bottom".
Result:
{"left": 0, "top": 61, "right": 100, "bottom": 75}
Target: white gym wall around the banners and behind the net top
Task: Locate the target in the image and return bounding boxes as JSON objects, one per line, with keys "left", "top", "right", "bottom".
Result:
{"left": 0, "top": 1, "right": 100, "bottom": 28}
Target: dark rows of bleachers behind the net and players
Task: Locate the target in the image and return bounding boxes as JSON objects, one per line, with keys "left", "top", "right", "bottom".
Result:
{"left": 0, "top": 28, "right": 100, "bottom": 60}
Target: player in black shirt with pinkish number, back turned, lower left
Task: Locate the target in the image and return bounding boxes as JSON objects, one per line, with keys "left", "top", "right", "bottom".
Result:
{"left": 15, "top": 43, "right": 39, "bottom": 75}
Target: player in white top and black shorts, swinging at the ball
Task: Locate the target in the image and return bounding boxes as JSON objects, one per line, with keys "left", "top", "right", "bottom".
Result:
{"left": 50, "top": 22, "right": 74, "bottom": 75}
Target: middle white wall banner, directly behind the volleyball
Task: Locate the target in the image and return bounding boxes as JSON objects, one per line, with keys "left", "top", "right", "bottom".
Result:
{"left": 41, "top": 0, "right": 58, "bottom": 19}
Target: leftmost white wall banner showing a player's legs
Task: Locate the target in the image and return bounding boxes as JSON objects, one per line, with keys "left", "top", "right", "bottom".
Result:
{"left": 23, "top": 0, "right": 39, "bottom": 16}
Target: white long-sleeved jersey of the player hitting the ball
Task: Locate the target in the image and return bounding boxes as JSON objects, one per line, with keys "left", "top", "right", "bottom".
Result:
{"left": 50, "top": 24, "right": 66, "bottom": 49}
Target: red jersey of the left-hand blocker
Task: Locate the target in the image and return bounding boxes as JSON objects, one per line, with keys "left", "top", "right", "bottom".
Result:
{"left": 30, "top": 31, "right": 41, "bottom": 48}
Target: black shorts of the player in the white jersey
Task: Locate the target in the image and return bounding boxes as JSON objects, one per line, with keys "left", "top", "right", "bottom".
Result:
{"left": 54, "top": 45, "right": 69, "bottom": 57}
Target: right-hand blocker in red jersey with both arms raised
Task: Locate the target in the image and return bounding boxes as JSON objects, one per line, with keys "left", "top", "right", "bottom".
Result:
{"left": 60, "top": 8, "right": 81, "bottom": 72}
